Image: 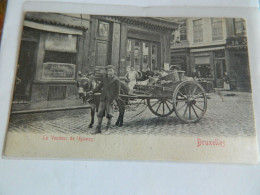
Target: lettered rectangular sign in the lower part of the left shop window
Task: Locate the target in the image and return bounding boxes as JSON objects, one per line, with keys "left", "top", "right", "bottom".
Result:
{"left": 42, "top": 62, "right": 76, "bottom": 80}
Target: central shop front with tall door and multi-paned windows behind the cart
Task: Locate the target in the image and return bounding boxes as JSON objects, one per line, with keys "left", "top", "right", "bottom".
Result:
{"left": 87, "top": 16, "right": 177, "bottom": 78}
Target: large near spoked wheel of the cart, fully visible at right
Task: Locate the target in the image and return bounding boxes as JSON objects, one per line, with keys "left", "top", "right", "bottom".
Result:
{"left": 173, "top": 81, "right": 207, "bottom": 123}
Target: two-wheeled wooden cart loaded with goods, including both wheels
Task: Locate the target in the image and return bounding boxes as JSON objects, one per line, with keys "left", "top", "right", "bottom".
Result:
{"left": 123, "top": 70, "right": 207, "bottom": 123}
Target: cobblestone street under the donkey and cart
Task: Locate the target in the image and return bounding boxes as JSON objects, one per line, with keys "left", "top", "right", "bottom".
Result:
{"left": 9, "top": 91, "right": 255, "bottom": 136}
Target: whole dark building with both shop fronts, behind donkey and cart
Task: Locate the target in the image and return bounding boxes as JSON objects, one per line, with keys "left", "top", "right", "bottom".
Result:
{"left": 14, "top": 12, "right": 178, "bottom": 102}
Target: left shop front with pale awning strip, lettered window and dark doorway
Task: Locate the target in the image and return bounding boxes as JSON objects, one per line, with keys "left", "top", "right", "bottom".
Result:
{"left": 14, "top": 13, "right": 88, "bottom": 102}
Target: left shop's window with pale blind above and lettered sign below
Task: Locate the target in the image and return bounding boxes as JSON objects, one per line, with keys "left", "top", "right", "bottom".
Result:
{"left": 42, "top": 33, "right": 77, "bottom": 80}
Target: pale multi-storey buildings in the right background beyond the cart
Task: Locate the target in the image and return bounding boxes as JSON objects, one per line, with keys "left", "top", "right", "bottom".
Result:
{"left": 171, "top": 18, "right": 251, "bottom": 91}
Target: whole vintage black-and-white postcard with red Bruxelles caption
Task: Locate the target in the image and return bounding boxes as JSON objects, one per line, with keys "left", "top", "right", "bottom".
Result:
{"left": 3, "top": 12, "right": 258, "bottom": 163}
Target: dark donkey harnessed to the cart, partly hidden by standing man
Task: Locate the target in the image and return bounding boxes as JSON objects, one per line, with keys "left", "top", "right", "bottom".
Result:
{"left": 77, "top": 75, "right": 129, "bottom": 128}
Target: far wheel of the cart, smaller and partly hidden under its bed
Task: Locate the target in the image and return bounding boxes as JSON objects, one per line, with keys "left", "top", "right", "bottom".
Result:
{"left": 147, "top": 98, "right": 174, "bottom": 117}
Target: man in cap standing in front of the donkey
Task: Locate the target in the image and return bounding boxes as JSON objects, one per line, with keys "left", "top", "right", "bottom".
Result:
{"left": 92, "top": 65, "right": 120, "bottom": 134}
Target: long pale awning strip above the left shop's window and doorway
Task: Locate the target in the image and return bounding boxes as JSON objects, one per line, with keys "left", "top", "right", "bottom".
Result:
{"left": 23, "top": 20, "right": 82, "bottom": 35}
